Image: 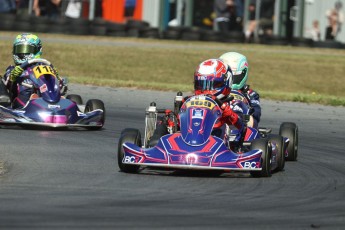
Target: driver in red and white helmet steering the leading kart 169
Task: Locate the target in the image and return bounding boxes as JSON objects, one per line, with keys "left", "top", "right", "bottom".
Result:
{"left": 150, "top": 59, "right": 246, "bottom": 146}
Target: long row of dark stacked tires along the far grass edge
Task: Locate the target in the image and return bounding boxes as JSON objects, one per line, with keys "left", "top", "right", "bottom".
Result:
{"left": 0, "top": 14, "right": 345, "bottom": 49}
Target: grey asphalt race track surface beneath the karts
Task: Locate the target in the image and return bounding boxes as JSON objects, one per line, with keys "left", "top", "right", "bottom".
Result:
{"left": 0, "top": 85, "right": 345, "bottom": 229}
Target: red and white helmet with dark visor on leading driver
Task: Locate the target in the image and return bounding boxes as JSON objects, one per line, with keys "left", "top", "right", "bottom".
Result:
{"left": 194, "top": 59, "right": 232, "bottom": 99}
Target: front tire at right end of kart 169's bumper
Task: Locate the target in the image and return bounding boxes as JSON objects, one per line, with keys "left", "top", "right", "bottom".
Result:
{"left": 250, "top": 138, "right": 272, "bottom": 177}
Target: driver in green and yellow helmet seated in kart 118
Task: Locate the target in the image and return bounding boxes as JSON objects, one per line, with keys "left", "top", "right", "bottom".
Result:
{"left": 0, "top": 33, "right": 67, "bottom": 109}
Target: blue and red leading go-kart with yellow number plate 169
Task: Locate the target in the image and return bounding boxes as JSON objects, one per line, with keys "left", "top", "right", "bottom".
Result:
{"left": 117, "top": 95, "right": 284, "bottom": 177}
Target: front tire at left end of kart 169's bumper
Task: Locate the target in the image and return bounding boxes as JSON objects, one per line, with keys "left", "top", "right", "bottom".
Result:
{"left": 117, "top": 128, "right": 142, "bottom": 173}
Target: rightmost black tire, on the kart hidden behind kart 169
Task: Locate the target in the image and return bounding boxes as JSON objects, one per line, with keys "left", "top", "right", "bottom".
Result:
{"left": 279, "top": 122, "right": 298, "bottom": 161}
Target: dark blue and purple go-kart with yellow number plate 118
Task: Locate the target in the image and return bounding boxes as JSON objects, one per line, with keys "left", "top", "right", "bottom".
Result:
{"left": 0, "top": 59, "right": 105, "bottom": 130}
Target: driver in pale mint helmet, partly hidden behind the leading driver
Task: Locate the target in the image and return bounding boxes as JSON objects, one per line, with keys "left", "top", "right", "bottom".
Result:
{"left": 219, "top": 52, "right": 261, "bottom": 128}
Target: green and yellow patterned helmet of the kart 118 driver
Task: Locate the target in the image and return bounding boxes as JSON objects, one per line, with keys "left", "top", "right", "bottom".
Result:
{"left": 12, "top": 33, "right": 42, "bottom": 65}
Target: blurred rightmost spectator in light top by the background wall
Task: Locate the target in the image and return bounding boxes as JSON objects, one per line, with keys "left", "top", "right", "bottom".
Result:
{"left": 326, "top": 1, "right": 344, "bottom": 40}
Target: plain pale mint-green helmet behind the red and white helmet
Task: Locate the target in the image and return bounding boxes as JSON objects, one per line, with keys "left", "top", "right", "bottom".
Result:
{"left": 219, "top": 52, "right": 249, "bottom": 90}
